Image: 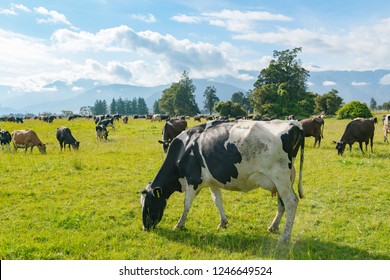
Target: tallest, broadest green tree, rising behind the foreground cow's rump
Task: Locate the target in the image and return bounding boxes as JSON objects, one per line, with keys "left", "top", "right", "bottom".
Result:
{"left": 252, "top": 48, "right": 314, "bottom": 117}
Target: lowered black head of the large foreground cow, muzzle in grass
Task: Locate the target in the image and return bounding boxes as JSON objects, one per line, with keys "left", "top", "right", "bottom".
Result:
{"left": 141, "top": 184, "right": 167, "bottom": 230}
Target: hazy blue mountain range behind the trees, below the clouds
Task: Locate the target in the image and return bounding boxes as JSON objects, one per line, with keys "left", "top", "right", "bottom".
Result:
{"left": 0, "top": 70, "right": 390, "bottom": 115}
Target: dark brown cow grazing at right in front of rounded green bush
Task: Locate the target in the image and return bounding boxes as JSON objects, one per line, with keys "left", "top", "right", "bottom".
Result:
{"left": 333, "top": 119, "right": 375, "bottom": 155}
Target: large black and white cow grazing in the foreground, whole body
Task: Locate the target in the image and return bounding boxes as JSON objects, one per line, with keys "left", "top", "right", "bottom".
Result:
{"left": 141, "top": 120, "right": 305, "bottom": 241}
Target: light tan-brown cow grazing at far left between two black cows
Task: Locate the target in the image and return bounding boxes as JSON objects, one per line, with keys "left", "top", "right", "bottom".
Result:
{"left": 12, "top": 129, "right": 46, "bottom": 154}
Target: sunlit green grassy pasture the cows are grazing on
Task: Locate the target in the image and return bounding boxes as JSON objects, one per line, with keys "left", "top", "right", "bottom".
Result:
{"left": 0, "top": 114, "right": 390, "bottom": 260}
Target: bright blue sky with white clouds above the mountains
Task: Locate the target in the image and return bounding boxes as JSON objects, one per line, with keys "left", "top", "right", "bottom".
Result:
{"left": 0, "top": 0, "right": 390, "bottom": 92}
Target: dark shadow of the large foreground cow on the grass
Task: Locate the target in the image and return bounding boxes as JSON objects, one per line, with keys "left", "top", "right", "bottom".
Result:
{"left": 156, "top": 228, "right": 390, "bottom": 260}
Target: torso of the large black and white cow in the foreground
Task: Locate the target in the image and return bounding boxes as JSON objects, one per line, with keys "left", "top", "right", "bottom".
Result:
{"left": 198, "top": 120, "right": 304, "bottom": 191}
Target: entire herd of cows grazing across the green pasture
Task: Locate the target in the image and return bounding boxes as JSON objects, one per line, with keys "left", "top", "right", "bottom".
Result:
{"left": 0, "top": 111, "right": 390, "bottom": 242}
